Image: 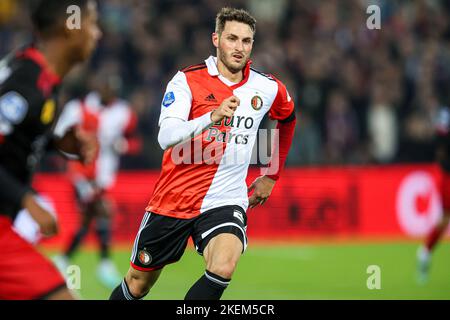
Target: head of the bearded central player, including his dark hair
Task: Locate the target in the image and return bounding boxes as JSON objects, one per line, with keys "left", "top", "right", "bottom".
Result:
{"left": 212, "top": 8, "right": 256, "bottom": 73}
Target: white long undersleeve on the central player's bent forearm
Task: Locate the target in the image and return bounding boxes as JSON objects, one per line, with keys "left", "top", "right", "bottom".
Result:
{"left": 158, "top": 112, "right": 213, "bottom": 150}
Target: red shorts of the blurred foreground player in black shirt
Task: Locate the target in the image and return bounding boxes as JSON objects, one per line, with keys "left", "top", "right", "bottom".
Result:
{"left": 0, "top": 217, "right": 66, "bottom": 300}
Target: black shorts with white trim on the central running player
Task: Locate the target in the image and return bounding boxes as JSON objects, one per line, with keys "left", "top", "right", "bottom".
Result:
{"left": 131, "top": 206, "right": 247, "bottom": 271}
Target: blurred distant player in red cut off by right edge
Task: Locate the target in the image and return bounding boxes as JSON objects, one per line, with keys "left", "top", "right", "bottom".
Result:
{"left": 417, "top": 107, "right": 450, "bottom": 283}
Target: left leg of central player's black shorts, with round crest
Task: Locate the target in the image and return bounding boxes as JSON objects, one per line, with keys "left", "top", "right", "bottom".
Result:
{"left": 130, "top": 212, "right": 193, "bottom": 272}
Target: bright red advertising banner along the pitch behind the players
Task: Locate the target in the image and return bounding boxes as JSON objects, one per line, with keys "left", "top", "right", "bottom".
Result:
{"left": 30, "top": 165, "right": 442, "bottom": 244}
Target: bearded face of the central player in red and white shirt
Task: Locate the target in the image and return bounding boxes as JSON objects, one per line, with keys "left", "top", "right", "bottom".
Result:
{"left": 213, "top": 21, "right": 253, "bottom": 73}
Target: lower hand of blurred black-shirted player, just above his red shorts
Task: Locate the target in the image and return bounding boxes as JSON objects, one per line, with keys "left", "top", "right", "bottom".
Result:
{"left": 22, "top": 193, "right": 58, "bottom": 237}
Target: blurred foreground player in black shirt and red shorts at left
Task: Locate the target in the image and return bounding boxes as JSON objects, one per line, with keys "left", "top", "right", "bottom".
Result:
{"left": 0, "top": 0, "right": 101, "bottom": 299}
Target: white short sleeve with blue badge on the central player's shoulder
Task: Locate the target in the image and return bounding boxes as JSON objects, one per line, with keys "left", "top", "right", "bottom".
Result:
{"left": 158, "top": 71, "right": 192, "bottom": 126}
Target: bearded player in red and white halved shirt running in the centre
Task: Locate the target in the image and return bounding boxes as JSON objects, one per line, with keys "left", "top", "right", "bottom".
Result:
{"left": 110, "top": 8, "right": 295, "bottom": 300}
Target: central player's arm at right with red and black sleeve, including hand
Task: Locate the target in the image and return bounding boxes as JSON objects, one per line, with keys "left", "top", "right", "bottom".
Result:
{"left": 248, "top": 78, "right": 296, "bottom": 208}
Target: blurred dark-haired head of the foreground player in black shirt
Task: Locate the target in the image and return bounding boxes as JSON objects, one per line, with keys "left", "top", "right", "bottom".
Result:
{"left": 31, "top": 0, "right": 101, "bottom": 63}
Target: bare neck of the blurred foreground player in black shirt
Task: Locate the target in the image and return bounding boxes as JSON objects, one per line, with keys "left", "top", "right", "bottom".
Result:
{"left": 36, "top": 41, "right": 73, "bottom": 79}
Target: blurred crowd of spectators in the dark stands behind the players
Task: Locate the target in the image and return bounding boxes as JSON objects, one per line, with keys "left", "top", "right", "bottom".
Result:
{"left": 0, "top": 0, "right": 450, "bottom": 169}
